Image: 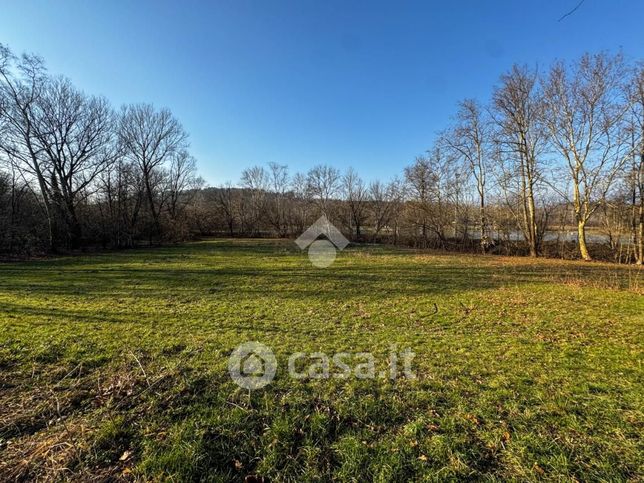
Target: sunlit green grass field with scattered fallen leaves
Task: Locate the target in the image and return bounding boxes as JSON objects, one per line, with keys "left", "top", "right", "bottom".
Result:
{"left": 0, "top": 240, "right": 644, "bottom": 481}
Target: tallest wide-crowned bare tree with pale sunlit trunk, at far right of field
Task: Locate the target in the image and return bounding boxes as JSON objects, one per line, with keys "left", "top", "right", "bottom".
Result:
{"left": 543, "top": 53, "right": 626, "bottom": 260}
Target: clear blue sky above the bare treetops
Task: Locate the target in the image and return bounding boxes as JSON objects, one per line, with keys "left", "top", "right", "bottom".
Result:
{"left": 0, "top": 0, "right": 644, "bottom": 185}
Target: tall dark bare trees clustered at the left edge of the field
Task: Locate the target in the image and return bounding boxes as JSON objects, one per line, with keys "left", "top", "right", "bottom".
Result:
{"left": 0, "top": 45, "right": 202, "bottom": 252}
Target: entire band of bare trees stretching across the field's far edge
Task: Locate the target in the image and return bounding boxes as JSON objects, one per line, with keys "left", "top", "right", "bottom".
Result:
{"left": 0, "top": 47, "right": 644, "bottom": 264}
